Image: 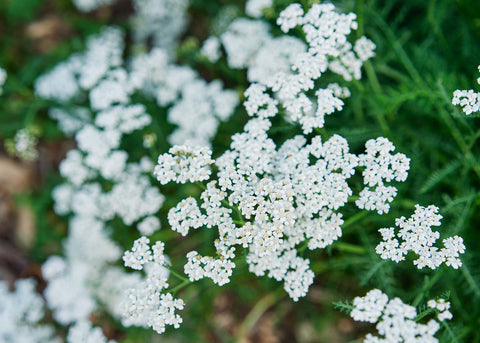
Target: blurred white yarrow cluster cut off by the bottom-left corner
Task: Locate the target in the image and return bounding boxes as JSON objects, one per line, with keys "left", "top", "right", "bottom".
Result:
{"left": 0, "top": 279, "right": 60, "bottom": 343}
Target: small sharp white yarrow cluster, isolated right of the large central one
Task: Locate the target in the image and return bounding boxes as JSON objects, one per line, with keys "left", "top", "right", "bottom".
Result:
{"left": 375, "top": 205, "right": 465, "bottom": 269}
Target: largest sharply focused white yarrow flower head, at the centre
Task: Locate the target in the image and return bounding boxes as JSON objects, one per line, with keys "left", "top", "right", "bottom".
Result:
{"left": 155, "top": 118, "right": 364, "bottom": 300}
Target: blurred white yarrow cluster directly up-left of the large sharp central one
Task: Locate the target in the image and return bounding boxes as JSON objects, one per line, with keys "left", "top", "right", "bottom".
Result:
{"left": 130, "top": 48, "right": 239, "bottom": 145}
